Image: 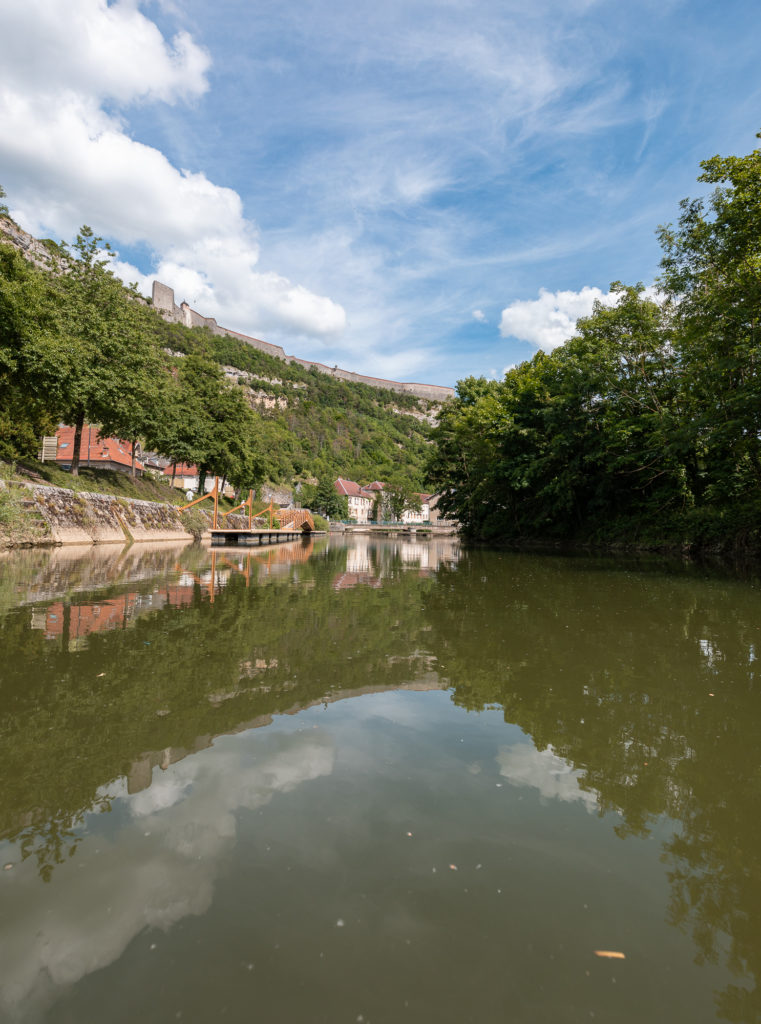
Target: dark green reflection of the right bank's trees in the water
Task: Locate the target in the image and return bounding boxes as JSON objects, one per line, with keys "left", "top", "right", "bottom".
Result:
{"left": 426, "top": 553, "right": 761, "bottom": 1022}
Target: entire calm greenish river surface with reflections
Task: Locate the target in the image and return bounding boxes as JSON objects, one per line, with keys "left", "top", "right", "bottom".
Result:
{"left": 0, "top": 537, "right": 761, "bottom": 1024}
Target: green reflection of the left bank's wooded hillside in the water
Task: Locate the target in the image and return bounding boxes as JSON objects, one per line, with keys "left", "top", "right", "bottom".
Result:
{"left": 0, "top": 545, "right": 446, "bottom": 880}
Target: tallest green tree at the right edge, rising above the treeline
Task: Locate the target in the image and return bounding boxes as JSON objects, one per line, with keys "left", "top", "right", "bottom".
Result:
{"left": 659, "top": 136, "right": 761, "bottom": 514}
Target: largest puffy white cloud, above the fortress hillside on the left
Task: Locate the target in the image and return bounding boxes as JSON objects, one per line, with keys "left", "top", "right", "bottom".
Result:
{"left": 0, "top": 0, "right": 346, "bottom": 337}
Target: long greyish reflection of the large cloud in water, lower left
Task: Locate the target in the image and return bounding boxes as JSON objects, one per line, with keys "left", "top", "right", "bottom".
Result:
{"left": 0, "top": 733, "right": 335, "bottom": 1020}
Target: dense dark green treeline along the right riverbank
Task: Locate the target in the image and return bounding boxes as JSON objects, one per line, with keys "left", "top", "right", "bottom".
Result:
{"left": 429, "top": 138, "right": 761, "bottom": 549}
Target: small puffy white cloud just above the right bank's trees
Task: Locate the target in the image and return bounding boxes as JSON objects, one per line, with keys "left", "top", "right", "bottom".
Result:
{"left": 500, "top": 285, "right": 617, "bottom": 352}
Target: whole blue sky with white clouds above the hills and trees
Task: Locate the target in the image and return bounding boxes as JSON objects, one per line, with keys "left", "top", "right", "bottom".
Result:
{"left": 0, "top": 0, "right": 761, "bottom": 384}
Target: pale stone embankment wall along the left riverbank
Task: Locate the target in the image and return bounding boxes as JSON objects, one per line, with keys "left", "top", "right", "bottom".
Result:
{"left": 0, "top": 484, "right": 244, "bottom": 547}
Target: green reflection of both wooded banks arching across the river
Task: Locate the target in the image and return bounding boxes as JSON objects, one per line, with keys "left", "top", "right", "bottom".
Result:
{"left": 5, "top": 547, "right": 761, "bottom": 1022}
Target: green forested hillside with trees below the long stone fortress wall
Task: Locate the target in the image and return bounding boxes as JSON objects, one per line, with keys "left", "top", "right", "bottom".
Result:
{"left": 0, "top": 196, "right": 435, "bottom": 489}
